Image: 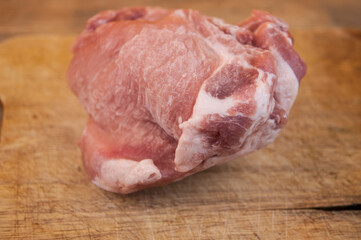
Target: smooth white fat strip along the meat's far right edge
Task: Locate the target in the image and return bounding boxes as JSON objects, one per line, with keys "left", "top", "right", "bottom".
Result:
{"left": 270, "top": 48, "right": 299, "bottom": 113}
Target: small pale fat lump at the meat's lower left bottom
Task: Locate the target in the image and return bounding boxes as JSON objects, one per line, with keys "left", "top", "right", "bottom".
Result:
{"left": 93, "top": 158, "right": 162, "bottom": 193}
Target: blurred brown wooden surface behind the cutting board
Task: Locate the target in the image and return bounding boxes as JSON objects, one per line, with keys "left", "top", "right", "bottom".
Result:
{"left": 0, "top": 0, "right": 361, "bottom": 40}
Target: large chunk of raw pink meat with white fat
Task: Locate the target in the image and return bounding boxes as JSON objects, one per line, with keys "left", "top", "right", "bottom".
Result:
{"left": 67, "top": 8, "right": 306, "bottom": 193}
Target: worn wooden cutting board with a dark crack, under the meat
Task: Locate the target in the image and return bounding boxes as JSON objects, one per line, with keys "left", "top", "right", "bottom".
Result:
{"left": 0, "top": 29, "right": 361, "bottom": 239}
